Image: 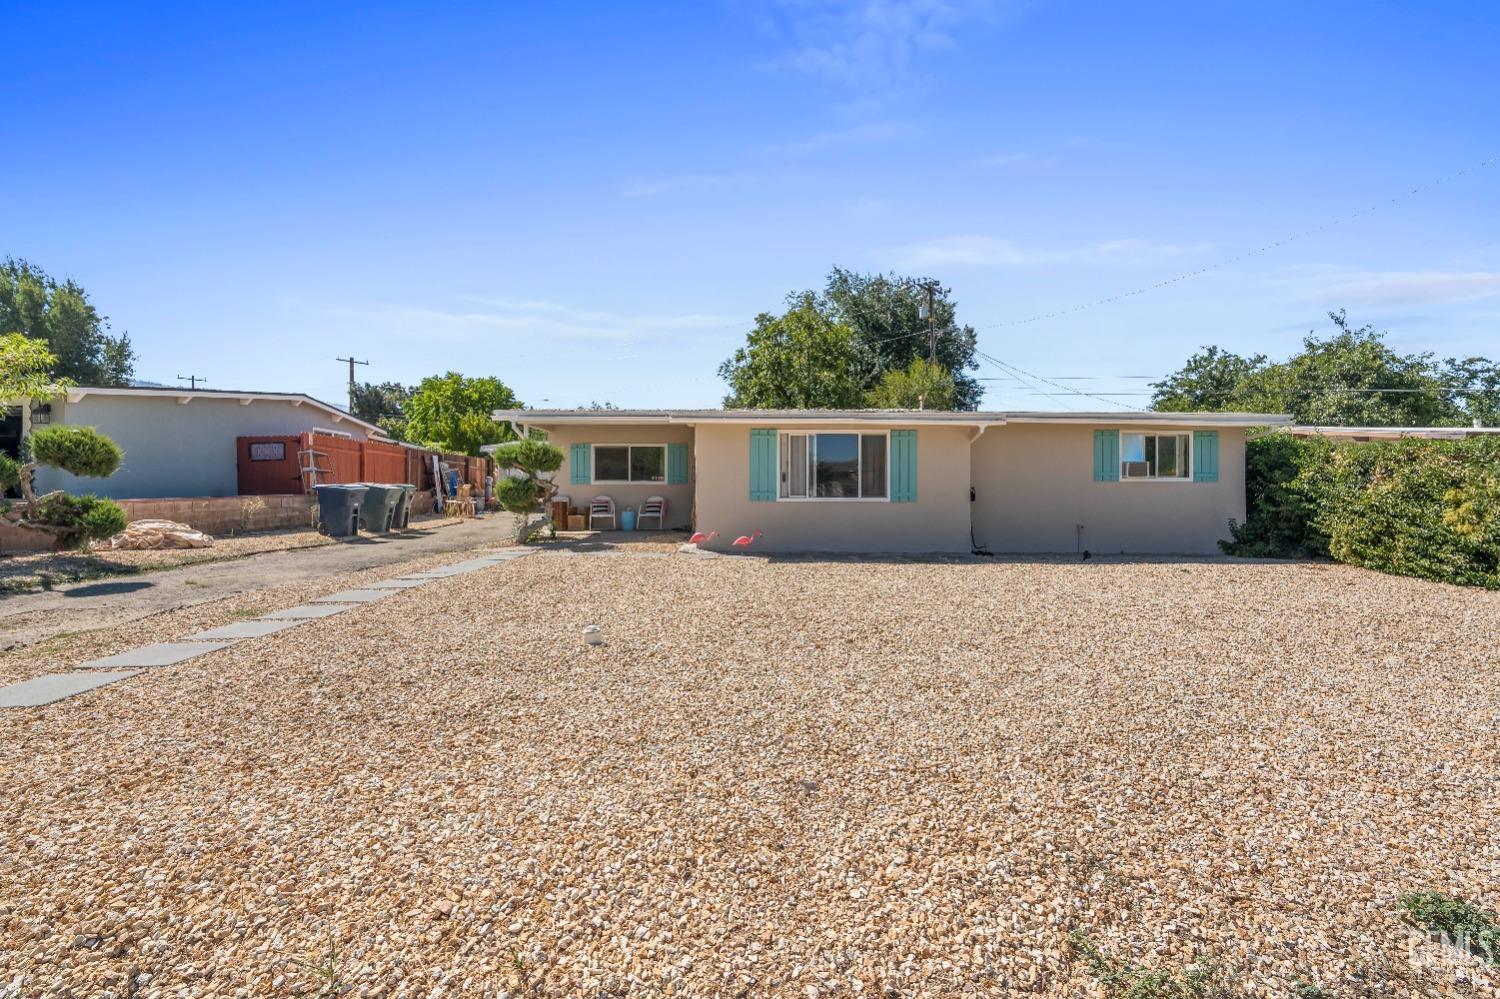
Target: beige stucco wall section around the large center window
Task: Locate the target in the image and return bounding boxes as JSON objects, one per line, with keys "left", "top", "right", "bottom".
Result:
{"left": 696, "top": 423, "right": 972, "bottom": 552}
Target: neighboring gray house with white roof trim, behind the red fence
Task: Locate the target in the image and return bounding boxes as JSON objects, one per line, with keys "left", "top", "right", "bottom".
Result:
{"left": 0, "top": 386, "right": 381, "bottom": 500}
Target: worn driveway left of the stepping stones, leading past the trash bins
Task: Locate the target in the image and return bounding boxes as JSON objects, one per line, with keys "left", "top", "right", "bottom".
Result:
{"left": 0, "top": 513, "right": 516, "bottom": 650}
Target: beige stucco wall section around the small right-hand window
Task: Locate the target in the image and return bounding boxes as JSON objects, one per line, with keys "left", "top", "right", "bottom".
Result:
{"left": 974, "top": 423, "right": 1245, "bottom": 555}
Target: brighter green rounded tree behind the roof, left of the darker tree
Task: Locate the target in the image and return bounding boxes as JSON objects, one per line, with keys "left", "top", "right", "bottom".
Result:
{"left": 719, "top": 291, "right": 866, "bottom": 410}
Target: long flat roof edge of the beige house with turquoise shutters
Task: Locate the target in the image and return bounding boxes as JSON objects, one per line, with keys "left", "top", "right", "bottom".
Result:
{"left": 494, "top": 410, "right": 1292, "bottom": 426}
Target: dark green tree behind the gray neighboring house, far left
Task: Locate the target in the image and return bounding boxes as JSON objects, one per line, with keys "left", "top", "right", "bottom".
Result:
{"left": 0, "top": 257, "right": 135, "bottom": 386}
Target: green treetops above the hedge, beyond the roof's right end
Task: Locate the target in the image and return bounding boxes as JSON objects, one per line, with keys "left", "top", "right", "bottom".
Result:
{"left": 1152, "top": 311, "right": 1476, "bottom": 426}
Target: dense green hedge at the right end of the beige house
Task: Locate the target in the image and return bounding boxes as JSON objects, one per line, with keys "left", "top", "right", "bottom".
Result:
{"left": 1224, "top": 434, "right": 1500, "bottom": 590}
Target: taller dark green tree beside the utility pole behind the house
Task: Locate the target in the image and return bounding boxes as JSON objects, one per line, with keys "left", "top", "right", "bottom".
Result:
{"left": 819, "top": 267, "right": 984, "bottom": 410}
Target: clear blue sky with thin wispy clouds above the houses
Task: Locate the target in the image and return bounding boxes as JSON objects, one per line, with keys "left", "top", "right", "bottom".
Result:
{"left": 0, "top": 0, "right": 1500, "bottom": 410}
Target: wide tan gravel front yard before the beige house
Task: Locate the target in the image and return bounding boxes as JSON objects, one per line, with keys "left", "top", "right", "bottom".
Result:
{"left": 0, "top": 548, "right": 1500, "bottom": 999}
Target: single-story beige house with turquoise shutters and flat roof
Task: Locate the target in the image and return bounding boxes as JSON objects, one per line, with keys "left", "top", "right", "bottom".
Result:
{"left": 495, "top": 410, "right": 1290, "bottom": 554}
